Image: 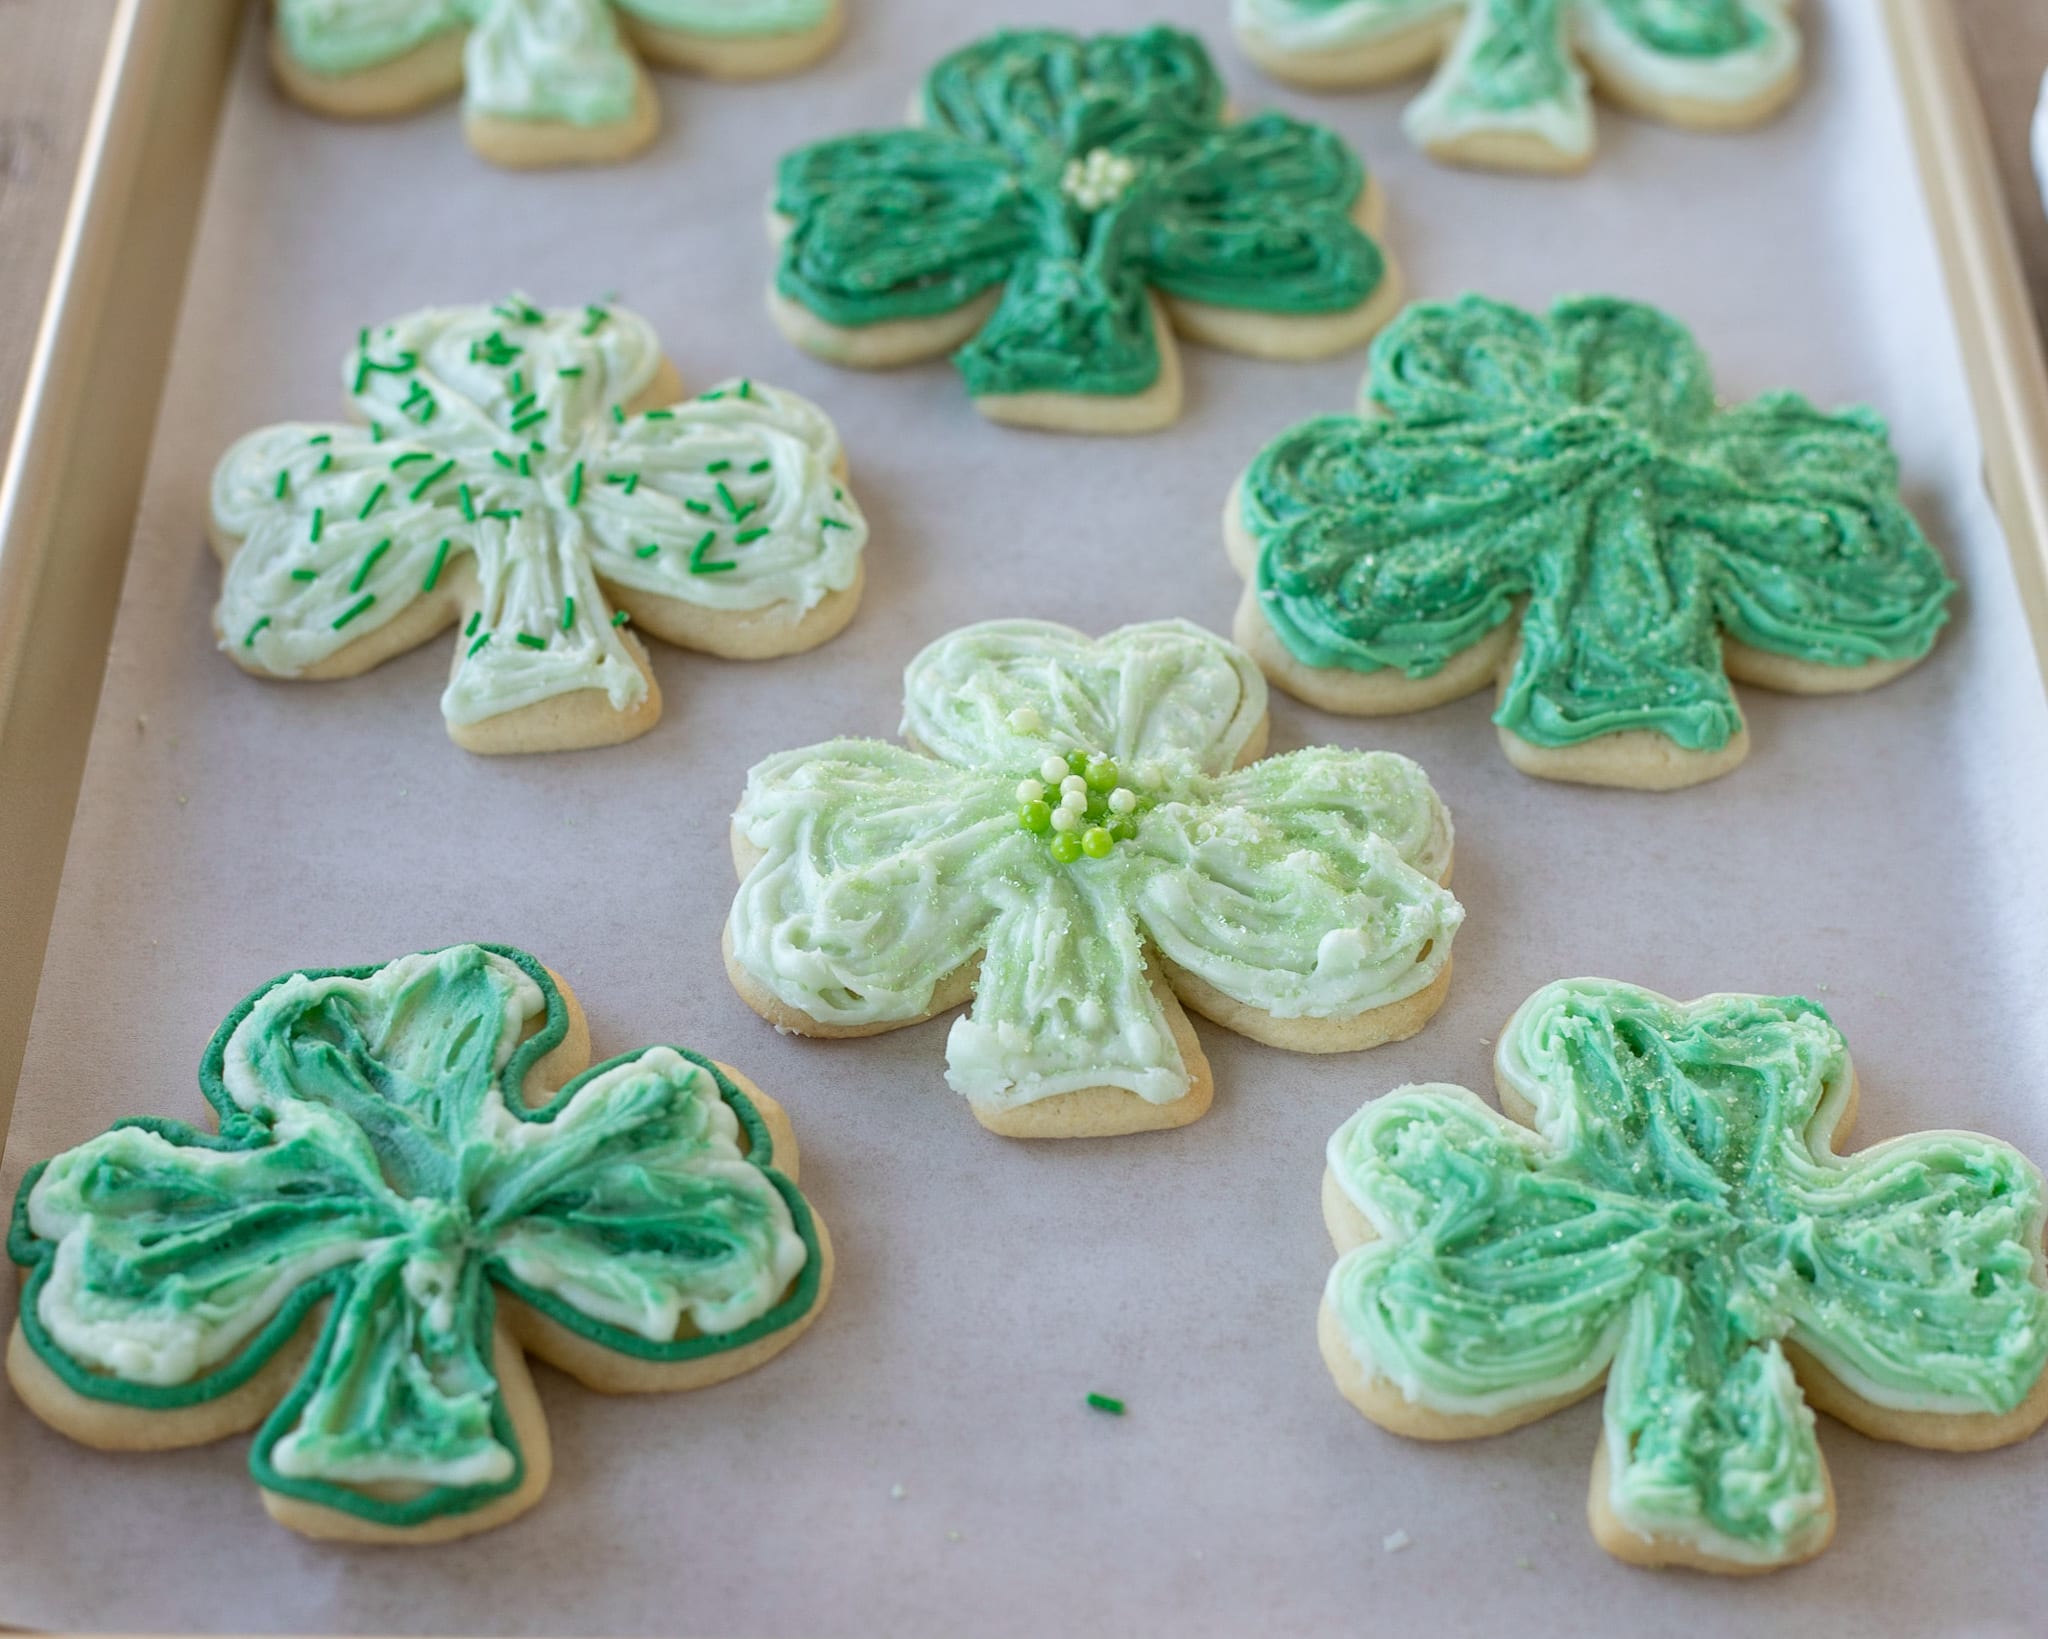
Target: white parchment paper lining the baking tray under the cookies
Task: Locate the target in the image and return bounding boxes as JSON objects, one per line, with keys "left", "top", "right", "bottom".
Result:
{"left": 0, "top": 0, "right": 2048, "bottom": 1639}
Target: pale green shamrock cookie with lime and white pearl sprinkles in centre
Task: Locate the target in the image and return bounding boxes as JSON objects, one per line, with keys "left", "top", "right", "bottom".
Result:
{"left": 725, "top": 621, "right": 1464, "bottom": 1137}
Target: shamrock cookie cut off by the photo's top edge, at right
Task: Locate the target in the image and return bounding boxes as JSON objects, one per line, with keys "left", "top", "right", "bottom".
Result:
{"left": 1233, "top": 0, "right": 1800, "bottom": 170}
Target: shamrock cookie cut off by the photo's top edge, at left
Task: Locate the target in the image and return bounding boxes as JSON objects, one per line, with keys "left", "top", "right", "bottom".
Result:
{"left": 270, "top": 0, "right": 842, "bottom": 166}
